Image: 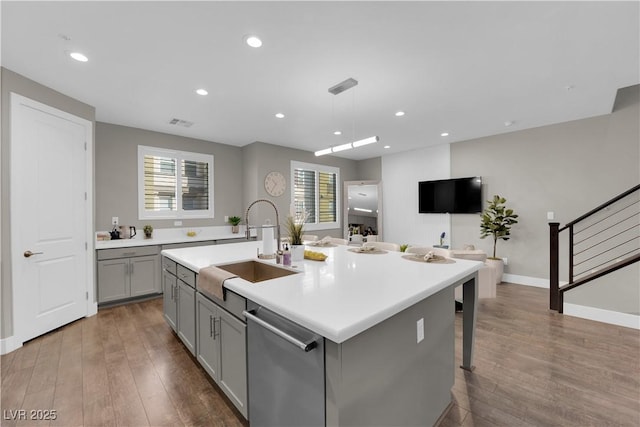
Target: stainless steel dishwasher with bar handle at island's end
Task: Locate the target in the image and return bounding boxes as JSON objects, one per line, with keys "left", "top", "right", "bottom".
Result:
{"left": 243, "top": 301, "right": 325, "bottom": 427}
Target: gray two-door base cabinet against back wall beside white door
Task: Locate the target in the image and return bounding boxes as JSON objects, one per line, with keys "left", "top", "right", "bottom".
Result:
{"left": 97, "top": 246, "right": 162, "bottom": 303}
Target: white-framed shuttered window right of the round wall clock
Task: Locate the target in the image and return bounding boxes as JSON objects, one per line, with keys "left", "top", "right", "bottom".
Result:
{"left": 291, "top": 162, "right": 340, "bottom": 230}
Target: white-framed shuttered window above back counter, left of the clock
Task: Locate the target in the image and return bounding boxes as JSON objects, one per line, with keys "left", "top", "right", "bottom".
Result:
{"left": 138, "top": 145, "right": 213, "bottom": 219}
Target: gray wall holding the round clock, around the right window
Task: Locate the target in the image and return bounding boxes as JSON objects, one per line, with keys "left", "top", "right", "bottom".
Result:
{"left": 241, "top": 142, "right": 360, "bottom": 237}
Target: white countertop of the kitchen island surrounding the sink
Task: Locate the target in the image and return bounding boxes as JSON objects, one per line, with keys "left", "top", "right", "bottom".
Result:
{"left": 162, "top": 241, "right": 482, "bottom": 343}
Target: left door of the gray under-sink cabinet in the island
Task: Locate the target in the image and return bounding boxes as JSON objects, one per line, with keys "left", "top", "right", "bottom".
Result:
{"left": 196, "top": 294, "right": 220, "bottom": 382}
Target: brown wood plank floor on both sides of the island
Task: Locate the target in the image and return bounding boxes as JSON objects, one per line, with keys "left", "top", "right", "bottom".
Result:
{"left": 0, "top": 284, "right": 640, "bottom": 427}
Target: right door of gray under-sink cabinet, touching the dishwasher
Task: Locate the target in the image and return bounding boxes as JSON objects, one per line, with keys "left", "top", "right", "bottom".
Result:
{"left": 217, "top": 309, "right": 247, "bottom": 418}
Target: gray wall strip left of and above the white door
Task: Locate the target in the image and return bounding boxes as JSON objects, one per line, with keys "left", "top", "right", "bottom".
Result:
{"left": 0, "top": 68, "right": 95, "bottom": 338}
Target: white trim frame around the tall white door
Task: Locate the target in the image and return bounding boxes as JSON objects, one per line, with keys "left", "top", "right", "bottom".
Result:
{"left": 10, "top": 92, "right": 97, "bottom": 349}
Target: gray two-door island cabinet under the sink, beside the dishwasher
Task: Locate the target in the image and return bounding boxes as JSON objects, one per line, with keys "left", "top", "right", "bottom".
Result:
{"left": 196, "top": 292, "right": 248, "bottom": 418}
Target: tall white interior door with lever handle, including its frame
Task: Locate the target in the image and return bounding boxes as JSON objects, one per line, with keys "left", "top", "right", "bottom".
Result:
{"left": 11, "top": 94, "right": 93, "bottom": 346}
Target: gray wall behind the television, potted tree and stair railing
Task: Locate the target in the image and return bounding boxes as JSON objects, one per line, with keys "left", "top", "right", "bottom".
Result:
{"left": 451, "top": 86, "right": 640, "bottom": 312}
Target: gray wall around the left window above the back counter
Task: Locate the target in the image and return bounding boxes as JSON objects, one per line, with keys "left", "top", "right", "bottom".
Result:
{"left": 95, "top": 122, "right": 244, "bottom": 230}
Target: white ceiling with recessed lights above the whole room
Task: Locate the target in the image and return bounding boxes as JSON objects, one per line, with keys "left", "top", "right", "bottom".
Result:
{"left": 1, "top": 1, "right": 640, "bottom": 159}
